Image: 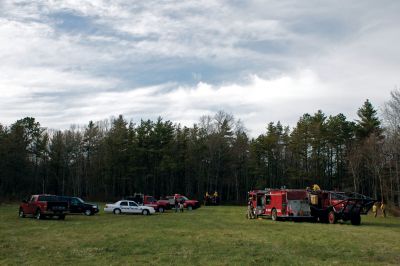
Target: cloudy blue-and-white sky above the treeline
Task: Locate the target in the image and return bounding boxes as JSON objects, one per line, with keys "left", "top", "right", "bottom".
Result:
{"left": 0, "top": 0, "right": 400, "bottom": 135}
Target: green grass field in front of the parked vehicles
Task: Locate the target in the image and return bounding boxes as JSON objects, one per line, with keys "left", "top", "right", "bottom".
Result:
{"left": 0, "top": 205, "right": 400, "bottom": 265}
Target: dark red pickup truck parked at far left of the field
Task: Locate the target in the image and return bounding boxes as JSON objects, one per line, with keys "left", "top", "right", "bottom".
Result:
{"left": 19, "top": 194, "right": 69, "bottom": 220}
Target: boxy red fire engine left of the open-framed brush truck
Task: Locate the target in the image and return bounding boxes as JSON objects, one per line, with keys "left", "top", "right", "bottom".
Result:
{"left": 249, "top": 189, "right": 314, "bottom": 221}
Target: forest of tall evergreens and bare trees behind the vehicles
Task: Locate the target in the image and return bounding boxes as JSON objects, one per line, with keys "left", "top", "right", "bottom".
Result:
{"left": 0, "top": 90, "right": 400, "bottom": 206}
